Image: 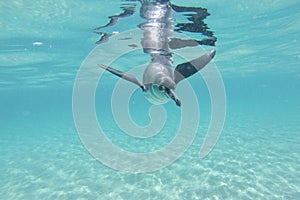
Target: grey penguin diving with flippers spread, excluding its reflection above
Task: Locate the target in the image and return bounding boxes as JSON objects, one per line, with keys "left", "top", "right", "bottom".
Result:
{"left": 99, "top": 50, "right": 216, "bottom": 106}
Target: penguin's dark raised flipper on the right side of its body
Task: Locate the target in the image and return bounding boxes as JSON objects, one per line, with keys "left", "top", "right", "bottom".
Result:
{"left": 174, "top": 49, "right": 216, "bottom": 84}
